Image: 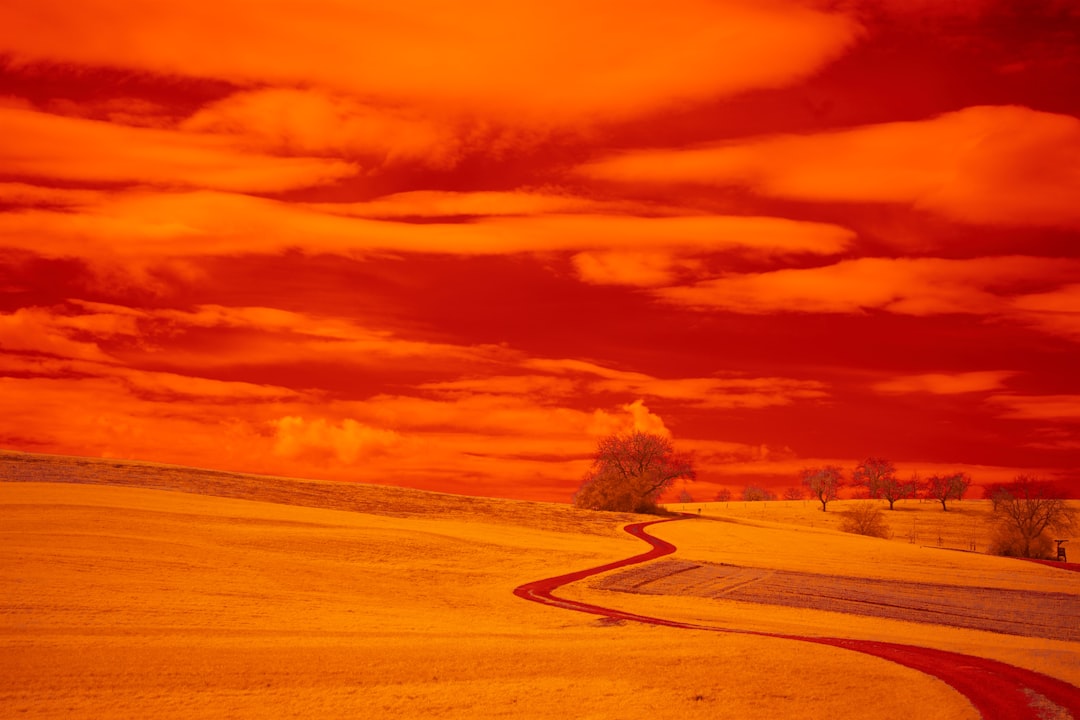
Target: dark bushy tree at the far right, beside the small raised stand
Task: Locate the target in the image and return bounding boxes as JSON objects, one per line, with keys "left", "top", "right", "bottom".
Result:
{"left": 991, "top": 475, "right": 1077, "bottom": 557}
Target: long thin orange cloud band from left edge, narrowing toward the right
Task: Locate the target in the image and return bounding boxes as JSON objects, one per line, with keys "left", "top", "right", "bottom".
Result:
{"left": 0, "top": 191, "right": 853, "bottom": 261}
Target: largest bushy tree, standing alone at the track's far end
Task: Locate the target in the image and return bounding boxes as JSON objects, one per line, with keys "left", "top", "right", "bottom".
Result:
{"left": 573, "top": 430, "right": 696, "bottom": 513}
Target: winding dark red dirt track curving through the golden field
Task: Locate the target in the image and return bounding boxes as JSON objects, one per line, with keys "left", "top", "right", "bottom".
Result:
{"left": 514, "top": 517, "right": 1080, "bottom": 720}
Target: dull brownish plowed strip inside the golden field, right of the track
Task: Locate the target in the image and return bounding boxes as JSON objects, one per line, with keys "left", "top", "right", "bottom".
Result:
{"left": 599, "top": 560, "right": 1080, "bottom": 641}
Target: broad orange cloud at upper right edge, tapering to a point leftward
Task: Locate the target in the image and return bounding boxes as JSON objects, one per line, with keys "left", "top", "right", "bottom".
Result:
{"left": 579, "top": 106, "right": 1080, "bottom": 227}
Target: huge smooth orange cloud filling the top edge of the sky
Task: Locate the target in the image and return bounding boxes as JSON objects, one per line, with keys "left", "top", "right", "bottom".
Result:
{"left": 0, "top": 0, "right": 861, "bottom": 126}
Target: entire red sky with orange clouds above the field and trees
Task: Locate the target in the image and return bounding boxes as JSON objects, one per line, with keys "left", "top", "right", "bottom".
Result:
{"left": 0, "top": 0, "right": 1080, "bottom": 502}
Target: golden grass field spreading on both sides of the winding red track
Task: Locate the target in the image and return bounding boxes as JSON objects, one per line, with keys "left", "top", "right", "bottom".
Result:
{"left": 0, "top": 453, "right": 1080, "bottom": 720}
